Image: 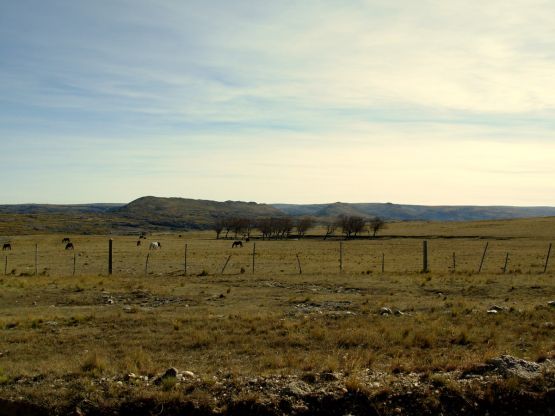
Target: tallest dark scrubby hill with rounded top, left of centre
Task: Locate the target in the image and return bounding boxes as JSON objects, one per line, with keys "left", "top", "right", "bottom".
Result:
{"left": 111, "top": 196, "right": 284, "bottom": 229}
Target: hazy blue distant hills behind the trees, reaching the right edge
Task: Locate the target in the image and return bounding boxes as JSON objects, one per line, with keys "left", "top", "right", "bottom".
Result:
{"left": 273, "top": 202, "right": 555, "bottom": 221}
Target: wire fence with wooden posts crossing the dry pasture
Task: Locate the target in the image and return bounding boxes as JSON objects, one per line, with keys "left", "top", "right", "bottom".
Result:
{"left": 1, "top": 236, "right": 551, "bottom": 276}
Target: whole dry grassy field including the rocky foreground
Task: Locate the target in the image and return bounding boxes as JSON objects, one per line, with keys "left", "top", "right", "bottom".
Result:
{"left": 0, "top": 219, "right": 555, "bottom": 414}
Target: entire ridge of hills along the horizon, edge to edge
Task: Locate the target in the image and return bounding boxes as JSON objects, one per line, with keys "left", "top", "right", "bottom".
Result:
{"left": 0, "top": 196, "right": 555, "bottom": 235}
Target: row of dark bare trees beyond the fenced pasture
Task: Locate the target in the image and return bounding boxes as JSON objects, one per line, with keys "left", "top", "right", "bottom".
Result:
{"left": 212, "top": 215, "right": 385, "bottom": 240}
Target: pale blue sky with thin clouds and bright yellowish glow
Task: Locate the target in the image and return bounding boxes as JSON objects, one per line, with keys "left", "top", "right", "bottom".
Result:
{"left": 0, "top": 0, "right": 555, "bottom": 206}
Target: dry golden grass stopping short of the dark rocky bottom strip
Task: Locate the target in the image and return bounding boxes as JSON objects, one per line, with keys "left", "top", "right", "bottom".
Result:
{"left": 0, "top": 219, "right": 555, "bottom": 412}
